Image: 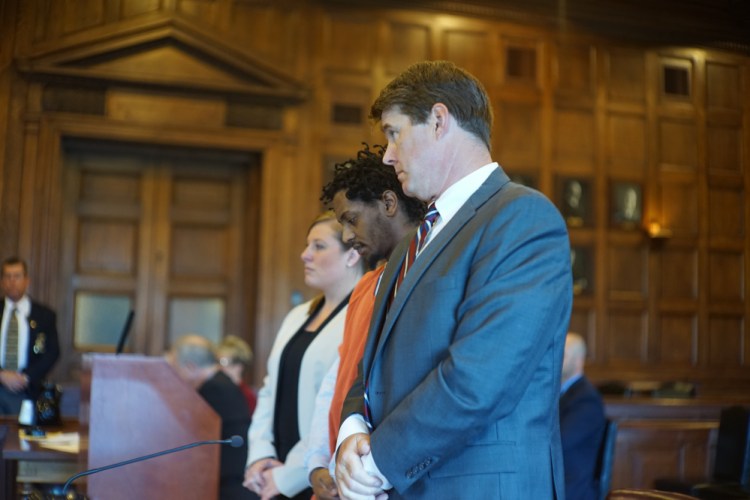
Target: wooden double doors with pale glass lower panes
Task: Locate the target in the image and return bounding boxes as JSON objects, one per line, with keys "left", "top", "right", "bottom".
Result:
{"left": 61, "top": 144, "right": 259, "bottom": 376}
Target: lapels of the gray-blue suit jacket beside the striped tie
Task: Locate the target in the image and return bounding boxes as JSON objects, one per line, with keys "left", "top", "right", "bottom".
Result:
{"left": 363, "top": 168, "right": 509, "bottom": 374}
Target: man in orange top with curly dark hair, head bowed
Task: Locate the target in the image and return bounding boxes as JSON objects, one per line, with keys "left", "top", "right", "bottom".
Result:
{"left": 308, "top": 145, "right": 425, "bottom": 500}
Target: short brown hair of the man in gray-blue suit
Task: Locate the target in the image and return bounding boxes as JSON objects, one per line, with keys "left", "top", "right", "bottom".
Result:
{"left": 370, "top": 61, "right": 492, "bottom": 149}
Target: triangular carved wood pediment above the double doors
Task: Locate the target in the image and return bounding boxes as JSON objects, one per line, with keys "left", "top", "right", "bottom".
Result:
{"left": 16, "top": 20, "right": 309, "bottom": 105}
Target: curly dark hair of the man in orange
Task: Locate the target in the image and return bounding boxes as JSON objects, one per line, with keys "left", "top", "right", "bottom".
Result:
{"left": 320, "top": 142, "right": 426, "bottom": 223}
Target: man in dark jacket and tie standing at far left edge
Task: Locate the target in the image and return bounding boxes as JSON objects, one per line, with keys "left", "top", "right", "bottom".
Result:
{"left": 0, "top": 257, "right": 60, "bottom": 415}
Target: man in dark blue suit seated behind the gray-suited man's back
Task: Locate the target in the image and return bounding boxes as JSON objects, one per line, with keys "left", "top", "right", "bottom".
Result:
{"left": 560, "top": 332, "right": 606, "bottom": 500}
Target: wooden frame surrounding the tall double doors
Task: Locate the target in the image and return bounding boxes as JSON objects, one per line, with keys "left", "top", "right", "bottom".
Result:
{"left": 18, "top": 114, "right": 296, "bottom": 382}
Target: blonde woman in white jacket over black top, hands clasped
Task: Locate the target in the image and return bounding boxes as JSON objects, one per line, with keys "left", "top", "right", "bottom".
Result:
{"left": 243, "top": 212, "right": 363, "bottom": 500}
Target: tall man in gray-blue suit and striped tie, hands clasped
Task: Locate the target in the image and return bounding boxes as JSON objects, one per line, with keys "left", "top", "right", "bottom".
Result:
{"left": 336, "top": 61, "right": 572, "bottom": 500}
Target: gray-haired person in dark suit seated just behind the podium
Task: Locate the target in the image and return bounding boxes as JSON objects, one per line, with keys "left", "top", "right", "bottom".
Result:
{"left": 167, "top": 334, "right": 258, "bottom": 500}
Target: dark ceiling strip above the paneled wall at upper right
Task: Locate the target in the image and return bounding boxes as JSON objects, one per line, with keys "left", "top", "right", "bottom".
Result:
{"left": 324, "top": 0, "right": 750, "bottom": 54}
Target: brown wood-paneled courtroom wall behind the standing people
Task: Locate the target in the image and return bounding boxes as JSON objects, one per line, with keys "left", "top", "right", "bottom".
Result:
{"left": 0, "top": 0, "right": 750, "bottom": 392}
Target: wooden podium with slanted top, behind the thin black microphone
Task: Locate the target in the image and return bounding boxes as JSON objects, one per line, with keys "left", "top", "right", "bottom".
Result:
{"left": 83, "top": 354, "right": 223, "bottom": 500}
